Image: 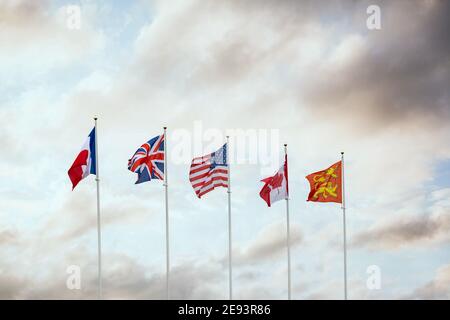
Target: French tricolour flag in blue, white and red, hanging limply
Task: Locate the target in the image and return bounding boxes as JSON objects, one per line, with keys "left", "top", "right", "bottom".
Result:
{"left": 67, "top": 128, "right": 97, "bottom": 190}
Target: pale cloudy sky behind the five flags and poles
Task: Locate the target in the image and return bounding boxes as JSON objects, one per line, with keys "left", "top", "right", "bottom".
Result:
{"left": 0, "top": 0, "right": 450, "bottom": 299}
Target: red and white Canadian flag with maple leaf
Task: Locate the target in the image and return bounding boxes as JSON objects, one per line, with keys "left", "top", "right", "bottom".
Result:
{"left": 259, "top": 155, "right": 289, "bottom": 207}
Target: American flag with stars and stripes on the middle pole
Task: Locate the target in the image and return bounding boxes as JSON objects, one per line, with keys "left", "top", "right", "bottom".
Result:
{"left": 189, "top": 144, "right": 228, "bottom": 198}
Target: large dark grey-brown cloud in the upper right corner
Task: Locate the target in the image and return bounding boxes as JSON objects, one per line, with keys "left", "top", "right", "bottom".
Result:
{"left": 302, "top": 1, "right": 450, "bottom": 127}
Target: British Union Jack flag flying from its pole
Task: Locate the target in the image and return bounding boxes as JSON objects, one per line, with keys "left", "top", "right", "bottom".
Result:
{"left": 128, "top": 134, "right": 164, "bottom": 184}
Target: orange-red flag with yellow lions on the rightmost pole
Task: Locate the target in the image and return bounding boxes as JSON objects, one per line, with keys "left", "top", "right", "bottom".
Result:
{"left": 306, "top": 161, "right": 342, "bottom": 203}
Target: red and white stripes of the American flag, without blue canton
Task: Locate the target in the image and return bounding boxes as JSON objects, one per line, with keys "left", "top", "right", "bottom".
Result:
{"left": 189, "top": 154, "right": 228, "bottom": 198}
